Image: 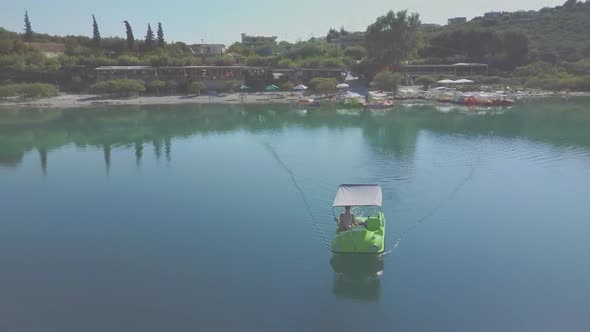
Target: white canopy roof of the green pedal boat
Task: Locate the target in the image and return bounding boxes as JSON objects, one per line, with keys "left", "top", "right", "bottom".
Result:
{"left": 334, "top": 184, "right": 383, "bottom": 207}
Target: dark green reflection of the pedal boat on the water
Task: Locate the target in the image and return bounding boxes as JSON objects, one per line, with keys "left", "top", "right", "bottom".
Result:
{"left": 330, "top": 254, "right": 384, "bottom": 302}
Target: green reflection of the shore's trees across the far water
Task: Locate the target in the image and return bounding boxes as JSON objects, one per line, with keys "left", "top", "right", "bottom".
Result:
{"left": 0, "top": 99, "right": 590, "bottom": 174}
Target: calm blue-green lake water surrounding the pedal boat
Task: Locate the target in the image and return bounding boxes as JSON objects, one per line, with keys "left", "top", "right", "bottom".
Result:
{"left": 0, "top": 99, "right": 590, "bottom": 332}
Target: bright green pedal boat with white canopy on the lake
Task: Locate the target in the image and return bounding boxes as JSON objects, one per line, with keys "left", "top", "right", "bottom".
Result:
{"left": 330, "top": 184, "right": 385, "bottom": 254}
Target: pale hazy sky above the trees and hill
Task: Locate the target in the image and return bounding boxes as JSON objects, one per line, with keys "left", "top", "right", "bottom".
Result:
{"left": 0, "top": 0, "right": 565, "bottom": 44}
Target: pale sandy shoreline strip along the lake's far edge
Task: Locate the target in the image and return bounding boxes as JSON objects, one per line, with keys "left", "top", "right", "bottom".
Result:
{"left": 0, "top": 89, "right": 590, "bottom": 109}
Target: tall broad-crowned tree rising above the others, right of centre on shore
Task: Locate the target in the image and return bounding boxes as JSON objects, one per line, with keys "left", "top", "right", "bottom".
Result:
{"left": 366, "top": 10, "right": 421, "bottom": 67}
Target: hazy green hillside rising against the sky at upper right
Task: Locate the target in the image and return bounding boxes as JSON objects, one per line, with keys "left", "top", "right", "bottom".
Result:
{"left": 434, "top": 0, "right": 590, "bottom": 61}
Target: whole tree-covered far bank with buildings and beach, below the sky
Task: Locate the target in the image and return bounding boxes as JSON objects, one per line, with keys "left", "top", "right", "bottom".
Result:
{"left": 0, "top": 0, "right": 590, "bottom": 106}
